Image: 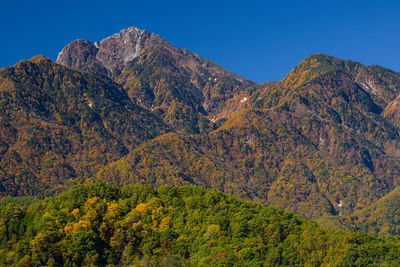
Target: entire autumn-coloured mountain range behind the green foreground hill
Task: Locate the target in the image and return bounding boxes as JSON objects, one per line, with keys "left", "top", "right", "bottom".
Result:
{"left": 0, "top": 27, "right": 400, "bottom": 237}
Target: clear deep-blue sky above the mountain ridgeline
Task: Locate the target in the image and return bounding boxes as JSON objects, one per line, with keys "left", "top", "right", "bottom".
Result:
{"left": 0, "top": 0, "right": 400, "bottom": 82}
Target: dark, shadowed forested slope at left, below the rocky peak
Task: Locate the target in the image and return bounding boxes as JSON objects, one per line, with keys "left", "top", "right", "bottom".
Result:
{"left": 0, "top": 56, "right": 167, "bottom": 195}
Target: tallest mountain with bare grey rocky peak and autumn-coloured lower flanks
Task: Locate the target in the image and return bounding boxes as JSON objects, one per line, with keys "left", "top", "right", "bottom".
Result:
{"left": 56, "top": 27, "right": 256, "bottom": 133}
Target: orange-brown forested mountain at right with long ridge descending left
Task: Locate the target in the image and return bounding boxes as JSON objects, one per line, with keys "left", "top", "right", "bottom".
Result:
{"left": 97, "top": 54, "right": 400, "bottom": 217}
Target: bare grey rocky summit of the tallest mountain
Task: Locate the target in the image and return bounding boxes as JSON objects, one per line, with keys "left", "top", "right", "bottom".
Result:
{"left": 56, "top": 27, "right": 231, "bottom": 80}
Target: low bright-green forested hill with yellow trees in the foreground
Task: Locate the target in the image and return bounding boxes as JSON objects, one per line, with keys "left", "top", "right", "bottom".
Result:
{"left": 0, "top": 183, "right": 400, "bottom": 266}
